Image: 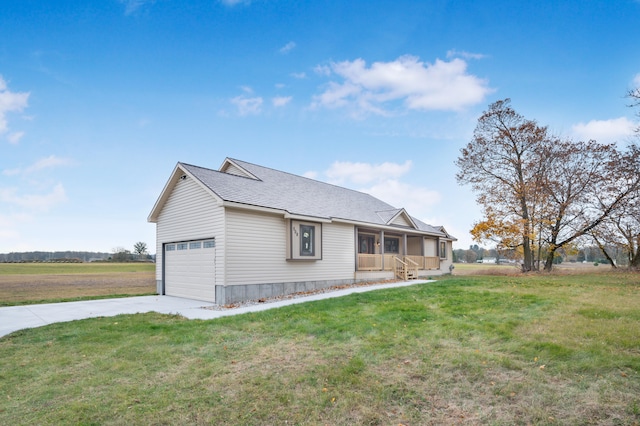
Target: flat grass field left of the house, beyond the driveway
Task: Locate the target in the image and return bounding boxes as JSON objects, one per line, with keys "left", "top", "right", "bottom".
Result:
{"left": 0, "top": 263, "right": 156, "bottom": 306}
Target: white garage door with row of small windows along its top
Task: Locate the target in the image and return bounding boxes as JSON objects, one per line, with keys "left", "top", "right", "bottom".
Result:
{"left": 164, "top": 239, "right": 216, "bottom": 302}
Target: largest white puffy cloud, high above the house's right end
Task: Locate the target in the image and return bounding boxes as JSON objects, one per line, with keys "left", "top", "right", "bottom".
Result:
{"left": 312, "top": 56, "right": 493, "bottom": 115}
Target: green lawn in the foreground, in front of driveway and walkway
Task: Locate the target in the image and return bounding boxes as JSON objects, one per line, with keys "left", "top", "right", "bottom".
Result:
{"left": 0, "top": 274, "right": 640, "bottom": 425}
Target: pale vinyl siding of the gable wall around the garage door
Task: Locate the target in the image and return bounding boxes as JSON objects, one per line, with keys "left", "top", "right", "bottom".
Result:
{"left": 156, "top": 178, "right": 224, "bottom": 280}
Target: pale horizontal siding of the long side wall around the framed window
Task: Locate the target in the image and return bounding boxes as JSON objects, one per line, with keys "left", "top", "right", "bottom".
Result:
{"left": 225, "top": 209, "right": 355, "bottom": 285}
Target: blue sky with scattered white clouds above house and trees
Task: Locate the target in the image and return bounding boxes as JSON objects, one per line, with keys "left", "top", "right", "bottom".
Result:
{"left": 0, "top": 0, "right": 640, "bottom": 252}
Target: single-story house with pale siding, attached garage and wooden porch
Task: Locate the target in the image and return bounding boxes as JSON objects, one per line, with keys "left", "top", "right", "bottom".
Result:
{"left": 148, "top": 158, "right": 455, "bottom": 304}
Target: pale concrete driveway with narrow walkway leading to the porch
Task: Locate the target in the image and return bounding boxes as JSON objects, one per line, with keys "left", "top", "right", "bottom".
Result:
{"left": 0, "top": 280, "right": 432, "bottom": 337}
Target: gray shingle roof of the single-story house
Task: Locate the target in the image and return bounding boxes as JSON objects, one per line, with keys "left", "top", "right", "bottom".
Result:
{"left": 179, "top": 159, "right": 447, "bottom": 237}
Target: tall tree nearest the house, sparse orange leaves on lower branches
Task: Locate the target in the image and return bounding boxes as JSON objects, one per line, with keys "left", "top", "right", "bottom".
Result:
{"left": 456, "top": 99, "right": 549, "bottom": 271}
